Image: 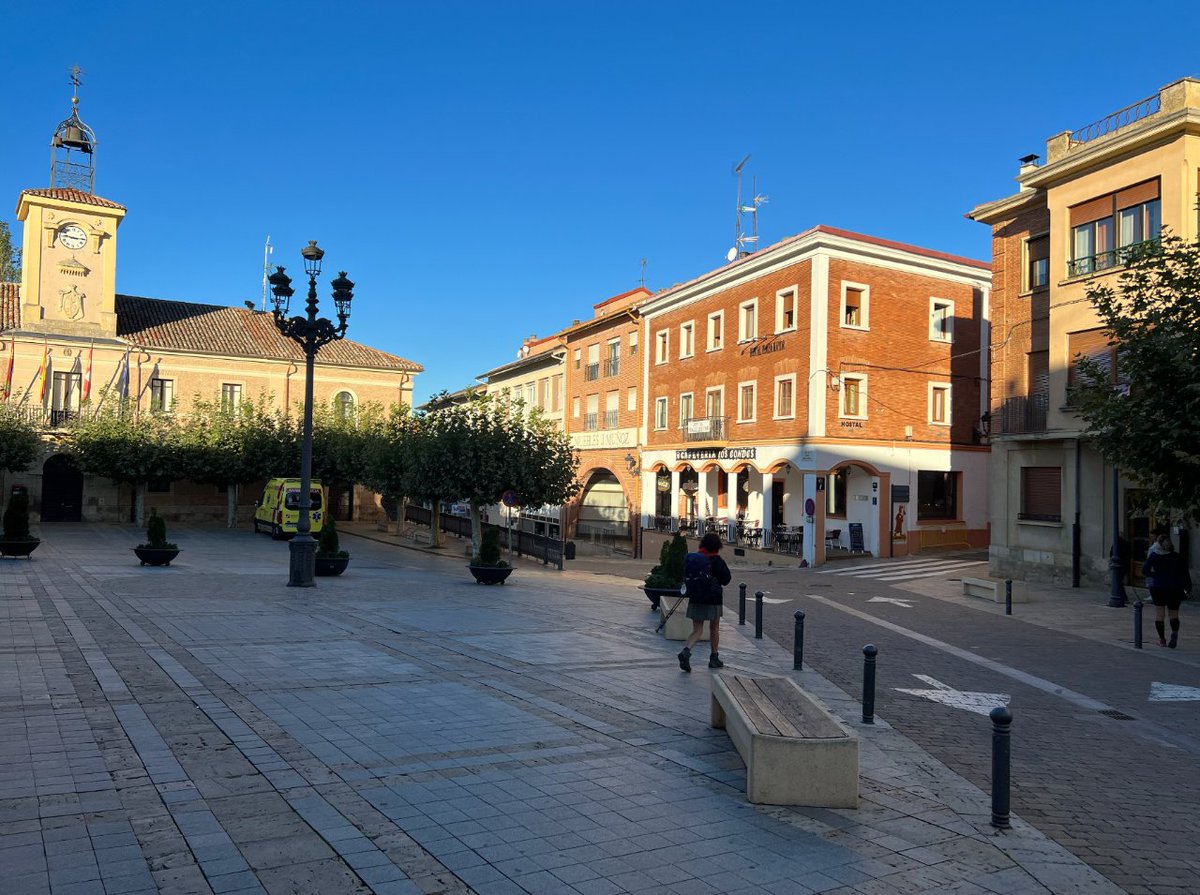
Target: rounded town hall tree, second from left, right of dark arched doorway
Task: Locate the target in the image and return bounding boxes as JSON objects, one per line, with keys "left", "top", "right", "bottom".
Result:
{"left": 70, "top": 400, "right": 185, "bottom": 527}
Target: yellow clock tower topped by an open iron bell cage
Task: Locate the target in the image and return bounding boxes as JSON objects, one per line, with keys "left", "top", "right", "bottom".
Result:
{"left": 17, "top": 70, "right": 125, "bottom": 337}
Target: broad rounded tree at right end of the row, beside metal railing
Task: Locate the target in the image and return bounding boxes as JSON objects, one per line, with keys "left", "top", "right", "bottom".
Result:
{"left": 407, "top": 396, "right": 580, "bottom": 555}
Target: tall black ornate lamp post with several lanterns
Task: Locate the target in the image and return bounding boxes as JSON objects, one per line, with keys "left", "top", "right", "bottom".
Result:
{"left": 268, "top": 240, "right": 354, "bottom": 588}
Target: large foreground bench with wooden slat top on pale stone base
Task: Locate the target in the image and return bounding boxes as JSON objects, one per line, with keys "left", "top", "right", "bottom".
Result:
{"left": 713, "top": 672, "right": 858, "bottom": 807}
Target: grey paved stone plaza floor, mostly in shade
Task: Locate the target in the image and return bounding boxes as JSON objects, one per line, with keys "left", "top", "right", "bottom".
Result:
{"left": 0, "top": 525, "right": 1118, "bottom": 895}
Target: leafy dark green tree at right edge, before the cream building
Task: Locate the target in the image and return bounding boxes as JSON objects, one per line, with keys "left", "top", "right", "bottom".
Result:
{"left": 1070, "top": 235, "right": 1200, "bottom": 521}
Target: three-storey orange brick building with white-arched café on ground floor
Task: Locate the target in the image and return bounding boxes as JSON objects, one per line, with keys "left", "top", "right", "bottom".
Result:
{"left": 640, "top": 227, "right": 990, "bottom": 564}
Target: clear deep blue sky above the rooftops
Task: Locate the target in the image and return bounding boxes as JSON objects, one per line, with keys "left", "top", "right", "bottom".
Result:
{"left": 0, "top": 0, "right": 1200, "bottom": 401}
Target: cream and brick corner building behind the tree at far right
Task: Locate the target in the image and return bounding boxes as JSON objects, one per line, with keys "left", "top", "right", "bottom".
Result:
{"left": 970, "top": 78, "right": 1200, "bottom": 584}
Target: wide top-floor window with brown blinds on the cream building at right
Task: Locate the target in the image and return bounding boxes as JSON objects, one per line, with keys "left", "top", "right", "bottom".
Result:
{"left": 1067, "top": 180, "right": 1162, "bottom": 269}
